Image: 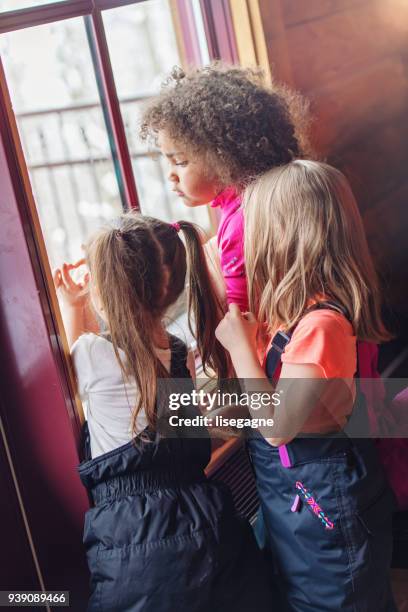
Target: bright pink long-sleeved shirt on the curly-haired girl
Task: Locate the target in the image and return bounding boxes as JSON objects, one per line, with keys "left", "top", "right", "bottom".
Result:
{"left": 211, "top": 187, "right": 248, "bottom": 312}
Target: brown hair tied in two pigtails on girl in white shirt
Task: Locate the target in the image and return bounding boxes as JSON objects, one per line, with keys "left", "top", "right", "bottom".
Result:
{"left": 87, "top": 212, "right": 227, "bottom": 434}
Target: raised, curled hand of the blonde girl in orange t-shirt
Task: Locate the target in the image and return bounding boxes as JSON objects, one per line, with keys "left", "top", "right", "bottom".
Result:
{"left": 215, "top": 304, "right": 258, "bottom": 355}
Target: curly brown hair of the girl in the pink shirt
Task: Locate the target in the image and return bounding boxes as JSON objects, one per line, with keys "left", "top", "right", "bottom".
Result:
{"left": 140, "top": 62, "right": 308, "bottom": 186}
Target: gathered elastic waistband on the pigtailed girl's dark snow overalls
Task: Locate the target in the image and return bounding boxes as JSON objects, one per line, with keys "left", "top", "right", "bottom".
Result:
{"left": 90, "top": 468, "right": 206, "bottom": 505}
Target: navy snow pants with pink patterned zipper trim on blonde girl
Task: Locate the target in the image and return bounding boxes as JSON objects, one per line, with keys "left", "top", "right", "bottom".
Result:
{"left": 248, "top": 435, "right": 396, "bottom": 612}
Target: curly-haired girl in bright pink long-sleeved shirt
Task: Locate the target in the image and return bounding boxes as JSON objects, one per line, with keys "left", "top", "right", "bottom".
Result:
{"left": 141, "top": 63, "right": 306, "bottom": 334}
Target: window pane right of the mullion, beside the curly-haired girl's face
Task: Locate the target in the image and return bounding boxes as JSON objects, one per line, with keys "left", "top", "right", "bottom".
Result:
{"left": 103, "top": 0, "right": 210, "bottom": 231}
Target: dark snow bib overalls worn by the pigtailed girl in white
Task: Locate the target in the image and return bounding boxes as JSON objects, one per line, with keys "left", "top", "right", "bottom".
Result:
{"left": 79, "top": 336, "right": 276, "bottom": 612}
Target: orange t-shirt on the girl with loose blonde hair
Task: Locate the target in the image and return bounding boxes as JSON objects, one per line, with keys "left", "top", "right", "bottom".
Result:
{"left": 270, "top": 310, "right": 357, "bottom": 433}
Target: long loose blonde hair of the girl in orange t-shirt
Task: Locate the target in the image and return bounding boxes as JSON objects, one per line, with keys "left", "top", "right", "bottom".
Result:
{"left": 243, "top": 160, "right": 389, "bottom": 342}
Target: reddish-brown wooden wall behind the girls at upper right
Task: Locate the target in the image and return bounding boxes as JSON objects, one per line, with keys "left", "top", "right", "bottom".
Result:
{"left": 259, "top": 0, "right": 408, "bottom": 316}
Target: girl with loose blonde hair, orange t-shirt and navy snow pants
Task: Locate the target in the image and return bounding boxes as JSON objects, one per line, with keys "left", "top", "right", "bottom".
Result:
{"left": 216, "top": 160, "right": 395, "bottom": 612}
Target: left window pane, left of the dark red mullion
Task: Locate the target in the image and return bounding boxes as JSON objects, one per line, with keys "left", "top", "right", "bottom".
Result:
{"left": 0, "top": 18, "right": 122, "bottom": 267}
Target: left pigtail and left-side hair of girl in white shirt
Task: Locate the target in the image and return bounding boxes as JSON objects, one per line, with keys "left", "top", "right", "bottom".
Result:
{"left": 87, "top": 213, "right": 168, "bottom": 435}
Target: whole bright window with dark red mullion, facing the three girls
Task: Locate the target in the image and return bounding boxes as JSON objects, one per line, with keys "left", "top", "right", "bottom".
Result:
{"left": 0, "top": 0, "right": 239, "bottom": 402}
